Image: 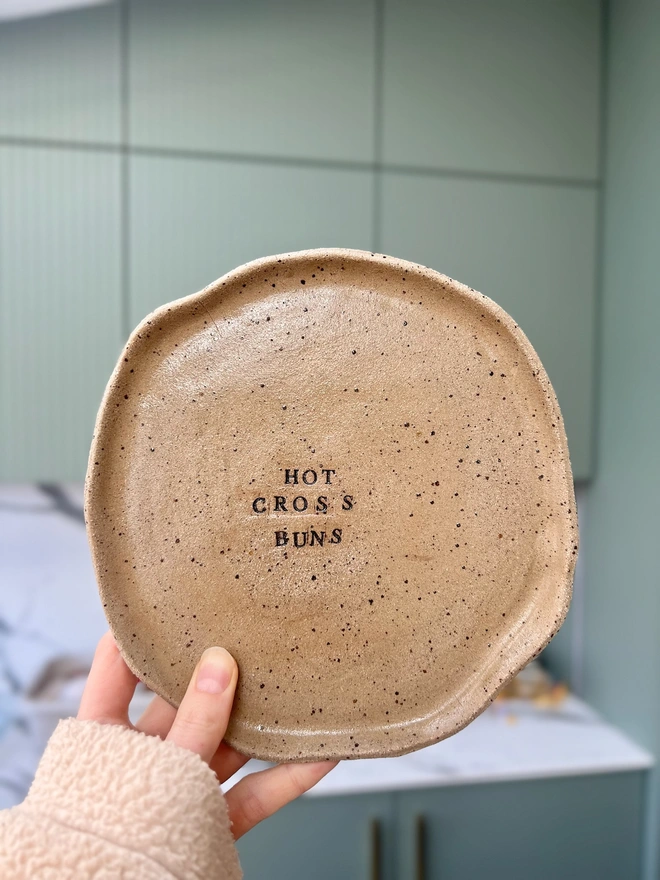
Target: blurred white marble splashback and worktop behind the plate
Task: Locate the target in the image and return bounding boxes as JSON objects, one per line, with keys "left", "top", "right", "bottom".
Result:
{"left": 0, "top": 486, "right": 653, "bottom": 807}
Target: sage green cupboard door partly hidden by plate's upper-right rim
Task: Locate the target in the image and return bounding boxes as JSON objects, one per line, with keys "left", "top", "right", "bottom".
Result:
{"left": 380, "top": 173, "right": 597, "bottom": 479}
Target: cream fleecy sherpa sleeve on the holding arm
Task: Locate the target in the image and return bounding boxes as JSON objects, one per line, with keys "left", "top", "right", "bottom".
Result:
{"left": 0, "top": 719, "right": 241, "bottom": 880}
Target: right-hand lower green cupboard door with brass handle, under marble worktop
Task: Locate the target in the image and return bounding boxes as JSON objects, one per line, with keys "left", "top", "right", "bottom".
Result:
{"left": 395, "top": 773, "right": 643, "bottom": 880}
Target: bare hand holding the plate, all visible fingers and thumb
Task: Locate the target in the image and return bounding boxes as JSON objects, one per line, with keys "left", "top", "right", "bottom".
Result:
{"left": 78, "top": 633, "right": 336, "bottom": 840}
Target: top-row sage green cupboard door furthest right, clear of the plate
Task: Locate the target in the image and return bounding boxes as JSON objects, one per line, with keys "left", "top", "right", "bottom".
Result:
{"left": 383, "top": 0, "right": 602, "bottom": 180}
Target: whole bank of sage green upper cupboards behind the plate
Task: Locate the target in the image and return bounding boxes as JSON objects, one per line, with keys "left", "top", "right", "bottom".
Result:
{"left": 0, "top": 0, "right": 601, "bottom": 480}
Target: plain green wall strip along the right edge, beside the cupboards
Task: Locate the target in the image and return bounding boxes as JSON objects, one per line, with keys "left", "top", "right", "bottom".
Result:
{"left": 582, "top": 0, "right": 660, "bottom": 877}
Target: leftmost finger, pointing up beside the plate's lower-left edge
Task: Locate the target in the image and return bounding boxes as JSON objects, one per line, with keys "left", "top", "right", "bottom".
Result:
{"left": 78, "top": 632, "right": 138, "bottom": 726}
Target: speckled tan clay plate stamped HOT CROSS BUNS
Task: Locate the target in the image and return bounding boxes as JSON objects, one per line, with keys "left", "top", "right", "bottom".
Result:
{"left": 86, "top": 250, "right": 577, "bottom": 760}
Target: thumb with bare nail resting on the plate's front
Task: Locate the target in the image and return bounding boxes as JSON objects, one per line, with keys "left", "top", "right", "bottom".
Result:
{"left": 166, "top": 648, "right": 238, "bottom": 763}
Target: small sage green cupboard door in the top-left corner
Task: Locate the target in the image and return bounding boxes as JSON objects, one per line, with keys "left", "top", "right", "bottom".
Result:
{"left": 0, "top": 2, "right": 121, "bottom": 144}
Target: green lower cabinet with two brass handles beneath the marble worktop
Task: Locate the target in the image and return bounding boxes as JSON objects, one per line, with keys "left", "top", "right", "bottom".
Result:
{"left": 239, "top": 772, "right": 644, "bottom": 880}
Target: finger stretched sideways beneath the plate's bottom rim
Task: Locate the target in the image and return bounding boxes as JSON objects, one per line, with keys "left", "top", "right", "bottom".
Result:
{"left": 225, "top": 761, "right": 337, "bottom": 840}
